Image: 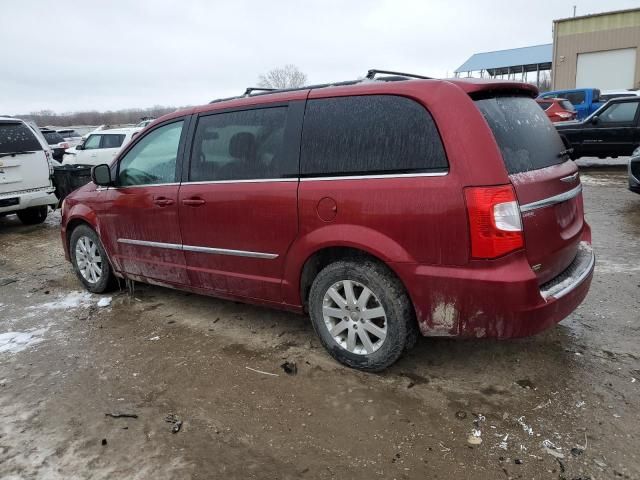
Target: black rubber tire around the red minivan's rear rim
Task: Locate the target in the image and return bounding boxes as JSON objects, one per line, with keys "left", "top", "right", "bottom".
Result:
{"left": 309, "top": 259, "right": 417, "bottom": 372}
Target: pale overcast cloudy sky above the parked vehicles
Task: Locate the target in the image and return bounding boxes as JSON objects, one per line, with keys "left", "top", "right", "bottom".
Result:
{"left": 0, "top": 0, "right": 637, "bottom": 114}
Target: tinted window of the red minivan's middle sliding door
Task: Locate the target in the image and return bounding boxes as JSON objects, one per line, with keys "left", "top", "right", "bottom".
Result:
{"left": 189, "top": 107, "right": 288, "bottom": 182}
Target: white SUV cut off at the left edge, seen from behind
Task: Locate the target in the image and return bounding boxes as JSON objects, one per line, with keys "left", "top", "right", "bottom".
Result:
{"left": 0, "top": 117, "right": 57, "bottom": 225}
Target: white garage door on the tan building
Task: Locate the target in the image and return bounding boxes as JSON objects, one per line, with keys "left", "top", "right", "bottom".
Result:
{"left": 576, "top": 48, "right": 636, "bottom": 90}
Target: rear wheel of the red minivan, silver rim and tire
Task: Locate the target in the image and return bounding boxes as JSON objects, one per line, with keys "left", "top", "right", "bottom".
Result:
{"left": 309, "top": 260, "right": 417, "bottom": 372}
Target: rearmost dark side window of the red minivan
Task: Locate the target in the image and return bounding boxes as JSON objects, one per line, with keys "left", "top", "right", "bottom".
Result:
{"left": 300, "top": 95, "right": 448, "bottom": 177}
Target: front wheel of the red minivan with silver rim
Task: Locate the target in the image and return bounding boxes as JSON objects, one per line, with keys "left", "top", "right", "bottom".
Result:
{"left": 69, "top": 225, "right": 115, "bottom": 293}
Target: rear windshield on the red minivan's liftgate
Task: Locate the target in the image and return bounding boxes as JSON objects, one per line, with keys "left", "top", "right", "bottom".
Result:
{"left": 476, "top": 97, "right": 565, "bottom": 174}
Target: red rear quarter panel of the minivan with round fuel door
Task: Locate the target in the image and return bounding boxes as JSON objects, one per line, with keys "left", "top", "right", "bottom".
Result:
{"left": 284, "top": 81, "right": 509, "bottom": 305}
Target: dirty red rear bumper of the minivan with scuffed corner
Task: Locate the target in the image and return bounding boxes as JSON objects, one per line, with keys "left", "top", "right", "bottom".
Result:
{"left": 393, "top": 242, "right": 595, "bottom": 338}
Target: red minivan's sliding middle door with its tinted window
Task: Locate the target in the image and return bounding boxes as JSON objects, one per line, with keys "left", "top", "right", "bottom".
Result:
{"left": 179, "top": 102, "right": 303, "bottom": 302}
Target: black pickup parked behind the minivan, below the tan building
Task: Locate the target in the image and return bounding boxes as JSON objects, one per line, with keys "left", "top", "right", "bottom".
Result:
{"left": 556, "top": 96, "right": 640, "bottom": 159}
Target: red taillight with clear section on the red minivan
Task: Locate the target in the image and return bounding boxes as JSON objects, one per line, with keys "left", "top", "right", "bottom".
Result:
{"left": 464, "top": 185, "right": 524, "bottom": 258}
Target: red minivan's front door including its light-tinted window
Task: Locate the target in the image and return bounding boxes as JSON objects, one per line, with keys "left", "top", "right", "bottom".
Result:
{"left": 99, "top": 119, "right": 189, "bottom": 285}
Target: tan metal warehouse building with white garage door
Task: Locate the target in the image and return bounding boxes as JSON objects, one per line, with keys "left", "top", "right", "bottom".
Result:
{"left": 553, "top": 8, "right": 640, "bottom": 90}
